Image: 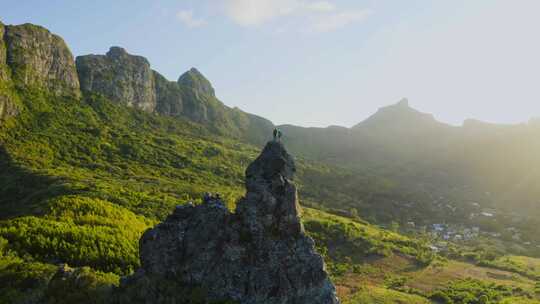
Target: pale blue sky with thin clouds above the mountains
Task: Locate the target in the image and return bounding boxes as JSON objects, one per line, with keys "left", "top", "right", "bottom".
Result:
{"left": 0, "top": 0, "right": 540, "bottom": 127}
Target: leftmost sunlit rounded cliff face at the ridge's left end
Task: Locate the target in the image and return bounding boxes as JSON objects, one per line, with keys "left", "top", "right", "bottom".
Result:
{"left": 0, "top": 24, "right": 80, "bottom": 96}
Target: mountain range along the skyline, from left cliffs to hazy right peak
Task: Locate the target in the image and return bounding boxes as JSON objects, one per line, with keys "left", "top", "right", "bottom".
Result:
{"left": 4, "top": 20, "right": 540, "bottom": 223}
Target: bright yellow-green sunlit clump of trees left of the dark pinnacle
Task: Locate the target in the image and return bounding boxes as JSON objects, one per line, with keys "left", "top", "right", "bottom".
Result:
{"left": 0, "top": 195, "right": 151, "bottom": 274}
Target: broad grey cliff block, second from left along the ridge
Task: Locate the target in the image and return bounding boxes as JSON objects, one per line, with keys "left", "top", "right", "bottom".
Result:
{"left": 76, "top": 47, "right": 156, "bottom": 112}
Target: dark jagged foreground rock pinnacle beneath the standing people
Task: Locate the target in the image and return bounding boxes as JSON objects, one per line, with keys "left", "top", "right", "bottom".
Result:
{"left": 118, "top": 141, "right": 339, "bottom": 304}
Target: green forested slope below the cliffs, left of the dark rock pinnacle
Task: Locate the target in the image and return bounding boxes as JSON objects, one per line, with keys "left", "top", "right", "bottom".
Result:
{"left": 0, "top": 85, "right": 257, "bottom": 303}
